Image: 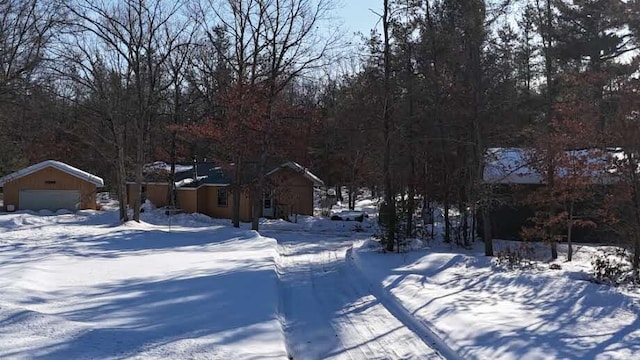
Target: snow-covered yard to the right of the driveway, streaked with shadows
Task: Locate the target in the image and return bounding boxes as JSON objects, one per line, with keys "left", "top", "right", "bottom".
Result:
{"left": 351, "top": 241, "right": 640, "bottom": 359}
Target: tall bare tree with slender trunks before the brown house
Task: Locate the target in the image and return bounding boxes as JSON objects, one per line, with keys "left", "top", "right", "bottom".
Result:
{"left": 200, "top": 0, "right": 339, "bottom": 230}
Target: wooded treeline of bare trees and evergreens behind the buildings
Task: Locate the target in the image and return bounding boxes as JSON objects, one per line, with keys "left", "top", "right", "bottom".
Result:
{"left": 0, "top": 0, "right": 640, "bottom": 266}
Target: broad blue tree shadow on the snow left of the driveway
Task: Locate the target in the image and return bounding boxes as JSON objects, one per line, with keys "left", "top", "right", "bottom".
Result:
{"left": 15, "top": 269, "right": 277, "bottom": 359}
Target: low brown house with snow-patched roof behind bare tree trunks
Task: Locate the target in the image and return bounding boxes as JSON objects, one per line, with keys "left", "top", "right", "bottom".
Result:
{"left": 127, "top": 161, "right": 324, "bottom": 221}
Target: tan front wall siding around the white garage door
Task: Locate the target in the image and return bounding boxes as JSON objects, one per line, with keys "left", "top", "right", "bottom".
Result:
{"left": 3, "top": 167, "right": 96, "bottom": 209}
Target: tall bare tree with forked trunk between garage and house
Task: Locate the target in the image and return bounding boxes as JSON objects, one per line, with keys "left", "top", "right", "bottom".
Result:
{"left": 63, "top": 0, "right": 190, "bottom": 221}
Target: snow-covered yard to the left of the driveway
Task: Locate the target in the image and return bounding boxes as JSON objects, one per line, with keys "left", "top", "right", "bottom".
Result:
{"left": 0, "top": 212, "right": 287, "bottom": 359}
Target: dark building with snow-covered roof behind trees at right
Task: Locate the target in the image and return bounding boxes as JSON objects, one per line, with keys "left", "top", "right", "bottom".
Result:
{"left": 477, "top": 148, "right": 619, "bottom": 241}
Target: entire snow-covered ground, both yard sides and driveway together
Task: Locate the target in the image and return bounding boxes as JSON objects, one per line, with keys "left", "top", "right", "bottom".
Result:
{"left": 0, "top": 194, "right": 640, "bottom": 360}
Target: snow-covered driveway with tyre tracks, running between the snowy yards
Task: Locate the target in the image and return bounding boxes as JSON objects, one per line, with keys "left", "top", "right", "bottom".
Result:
{"left": 263, "top": 231, "right": 440, "bottom": 360}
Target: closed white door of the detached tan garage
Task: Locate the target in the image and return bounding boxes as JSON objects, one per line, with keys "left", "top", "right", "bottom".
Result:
{"left": 20, "top": 190, "right": 80, "bottom": 211}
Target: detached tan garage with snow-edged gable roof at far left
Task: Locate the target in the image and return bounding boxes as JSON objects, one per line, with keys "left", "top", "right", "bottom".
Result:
{"left": 0, "top": 160, "right": 104, "bottom": 211}
